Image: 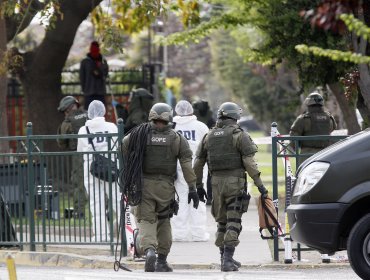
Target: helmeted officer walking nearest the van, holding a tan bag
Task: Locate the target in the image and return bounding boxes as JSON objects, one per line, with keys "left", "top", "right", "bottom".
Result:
{"left": 193, "top": 102, "right": 267, "bottom": 271}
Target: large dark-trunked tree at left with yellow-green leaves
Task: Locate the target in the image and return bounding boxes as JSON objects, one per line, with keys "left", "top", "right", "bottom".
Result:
{"left": 0, "top": 0, "right": 197, "bottom": 147}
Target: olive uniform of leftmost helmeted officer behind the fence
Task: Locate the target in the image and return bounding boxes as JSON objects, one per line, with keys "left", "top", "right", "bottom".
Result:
{"left": 57, "top": 109, "right": 87, "bottom": 216}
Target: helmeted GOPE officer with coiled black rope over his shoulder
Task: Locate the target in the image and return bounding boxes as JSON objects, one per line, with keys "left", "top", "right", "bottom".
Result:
{"left": 121, "top": 103, "right": 205, "bottom": 272}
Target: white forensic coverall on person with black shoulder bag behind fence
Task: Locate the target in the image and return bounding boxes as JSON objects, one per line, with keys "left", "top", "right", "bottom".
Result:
{"left": 77, "top": 100, "right": 120, "bottom": 242}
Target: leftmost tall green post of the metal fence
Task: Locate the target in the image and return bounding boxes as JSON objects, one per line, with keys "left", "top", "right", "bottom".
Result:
{"left": 26, "top": 122, "right": 36, "bottom": 251}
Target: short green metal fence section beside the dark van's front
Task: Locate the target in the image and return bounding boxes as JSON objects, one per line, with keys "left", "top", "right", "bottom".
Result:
{"left": 272, "top": 128, "right": 348, "bottom": 261}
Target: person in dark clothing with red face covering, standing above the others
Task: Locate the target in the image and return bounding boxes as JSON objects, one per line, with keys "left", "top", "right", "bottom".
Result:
{"left": 80, "top": 41, "right": 109, "bottom": 110}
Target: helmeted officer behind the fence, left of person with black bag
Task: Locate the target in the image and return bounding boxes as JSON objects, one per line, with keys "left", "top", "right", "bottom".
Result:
{"left": 57, "top": 96, "right": 87, "bottom": 218}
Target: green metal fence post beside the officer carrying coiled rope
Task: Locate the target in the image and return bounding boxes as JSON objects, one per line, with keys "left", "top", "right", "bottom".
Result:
{"left": 117, "top": 118, "right": 127, "bottom": 257}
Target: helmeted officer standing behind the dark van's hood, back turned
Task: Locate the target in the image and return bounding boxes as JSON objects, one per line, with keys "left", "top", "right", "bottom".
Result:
{"left": 289, "top": 91, "right": 337, "bottom": 162}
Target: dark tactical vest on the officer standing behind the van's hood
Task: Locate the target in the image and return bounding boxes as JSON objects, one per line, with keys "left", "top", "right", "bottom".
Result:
{"left": 302, "top": 112, "right": 332, "bottom": 148}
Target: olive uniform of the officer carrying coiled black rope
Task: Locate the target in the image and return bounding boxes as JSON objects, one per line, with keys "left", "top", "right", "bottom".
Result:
{"left": 122, "top": 122, "right": 195, "bottom": 252}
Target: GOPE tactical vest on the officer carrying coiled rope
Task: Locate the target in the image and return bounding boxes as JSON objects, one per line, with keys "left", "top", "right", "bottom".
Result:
{"left": 143, "top": 130, "right": 178, "bottom": 176}
